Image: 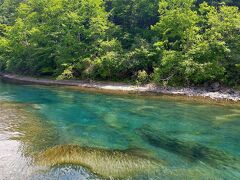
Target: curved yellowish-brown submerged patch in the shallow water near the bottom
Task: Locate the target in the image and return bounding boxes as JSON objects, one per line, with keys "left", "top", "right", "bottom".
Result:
{"left": 36, "top": 145, "right": 161, "bottom": 178}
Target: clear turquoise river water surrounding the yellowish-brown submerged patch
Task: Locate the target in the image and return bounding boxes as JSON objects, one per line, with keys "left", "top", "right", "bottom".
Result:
{"left": 0, "top": 79, "right": 240, "bottom": 179}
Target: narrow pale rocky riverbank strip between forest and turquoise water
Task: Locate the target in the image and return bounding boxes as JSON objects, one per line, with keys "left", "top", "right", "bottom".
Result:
{"left": 0, "top": 74, "right": 240, "bottom": 102}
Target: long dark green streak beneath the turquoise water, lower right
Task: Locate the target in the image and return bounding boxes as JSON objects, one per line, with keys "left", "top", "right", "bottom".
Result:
{"left": 137, "top": 126, "right": 239, "bottom": 168}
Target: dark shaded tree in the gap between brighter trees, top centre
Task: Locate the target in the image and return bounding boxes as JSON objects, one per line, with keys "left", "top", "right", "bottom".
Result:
{"left": 105, "top": 0, "right": 159, "bottom": 49}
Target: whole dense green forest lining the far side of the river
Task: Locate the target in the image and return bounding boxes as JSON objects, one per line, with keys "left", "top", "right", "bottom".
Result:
{"left": 0, "top": 0, "right": 240, "bottom": 86}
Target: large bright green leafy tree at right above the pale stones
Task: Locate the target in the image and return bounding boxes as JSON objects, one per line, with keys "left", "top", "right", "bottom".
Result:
{"left": 153, "top": 0, "right": 240, "bottom": 84}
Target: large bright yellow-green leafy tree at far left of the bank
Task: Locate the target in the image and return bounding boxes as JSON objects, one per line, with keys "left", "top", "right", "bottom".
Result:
{"left": 1, "top": 0, "right": 114, "bottom": 74}
